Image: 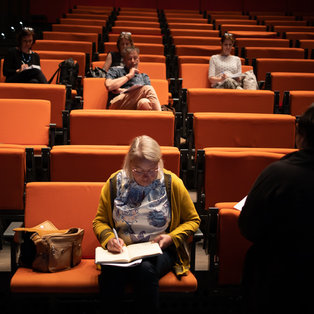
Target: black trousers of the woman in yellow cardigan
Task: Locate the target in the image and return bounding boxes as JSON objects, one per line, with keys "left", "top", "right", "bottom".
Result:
{"left": 98, "top": 246, "right": 176, "bottom": 313}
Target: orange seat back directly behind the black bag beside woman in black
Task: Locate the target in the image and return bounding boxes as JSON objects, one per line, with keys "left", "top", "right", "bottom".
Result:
{"left": 36, "top": 50, "right": 86, "bottom": 79}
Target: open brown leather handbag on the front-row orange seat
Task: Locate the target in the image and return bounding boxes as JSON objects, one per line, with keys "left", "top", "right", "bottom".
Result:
{"left": 15, "top": 221, "right": 84, "bottom": 272}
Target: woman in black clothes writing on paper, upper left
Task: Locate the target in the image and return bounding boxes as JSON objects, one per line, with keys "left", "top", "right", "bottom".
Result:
{"left": 3, "top": 27, "right": 47, "bottom": 84}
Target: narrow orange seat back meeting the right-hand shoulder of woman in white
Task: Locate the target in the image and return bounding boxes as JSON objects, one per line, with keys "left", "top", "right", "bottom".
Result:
{"left": 242, "top": 47, "right": 304, "bottom": 61}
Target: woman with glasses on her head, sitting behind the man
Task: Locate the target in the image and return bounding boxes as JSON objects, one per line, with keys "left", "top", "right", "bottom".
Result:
{"left": 103, "top": 32, "right": 134, "bottom": 72}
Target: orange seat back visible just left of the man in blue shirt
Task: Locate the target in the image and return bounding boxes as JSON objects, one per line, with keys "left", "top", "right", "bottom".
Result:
{"left": 83, "top": 77, "right": 108, "bottom": 109}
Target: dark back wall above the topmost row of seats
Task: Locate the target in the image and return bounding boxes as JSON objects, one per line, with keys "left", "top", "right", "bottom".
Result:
{"left": 0, "top": 0, "right": 314, "bottom": 26}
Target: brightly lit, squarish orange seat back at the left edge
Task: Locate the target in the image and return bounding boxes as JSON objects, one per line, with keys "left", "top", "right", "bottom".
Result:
{"left": 0, "top": 99, "right": 50, "bottom": 145}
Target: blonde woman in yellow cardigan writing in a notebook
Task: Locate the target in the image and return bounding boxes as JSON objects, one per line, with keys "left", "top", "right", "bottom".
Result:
{"left": 93, "top": 135, "right": 200, "bottom": 313}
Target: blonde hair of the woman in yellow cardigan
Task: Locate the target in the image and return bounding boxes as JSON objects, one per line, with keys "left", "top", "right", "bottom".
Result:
{"left": 123, "top": 135, "right": 164, "bottom": 178}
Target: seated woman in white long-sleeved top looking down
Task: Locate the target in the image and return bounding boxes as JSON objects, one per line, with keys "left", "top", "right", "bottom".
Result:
{"left": 208, "top": 33, "right": 242, "bottom": 89}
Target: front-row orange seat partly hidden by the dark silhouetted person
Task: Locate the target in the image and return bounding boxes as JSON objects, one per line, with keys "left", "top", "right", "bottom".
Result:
{"left": 217, "top": 208, "right": 251, "bottom": 285}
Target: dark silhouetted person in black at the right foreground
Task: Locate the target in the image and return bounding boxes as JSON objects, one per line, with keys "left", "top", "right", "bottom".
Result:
{"left": 239, "top": 103, "right": 314, "bottom": 314}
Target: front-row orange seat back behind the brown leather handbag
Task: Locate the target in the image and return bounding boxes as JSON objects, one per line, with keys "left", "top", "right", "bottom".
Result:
{"left": 25, "top": 182, "right": 104, "bottom": 258}
